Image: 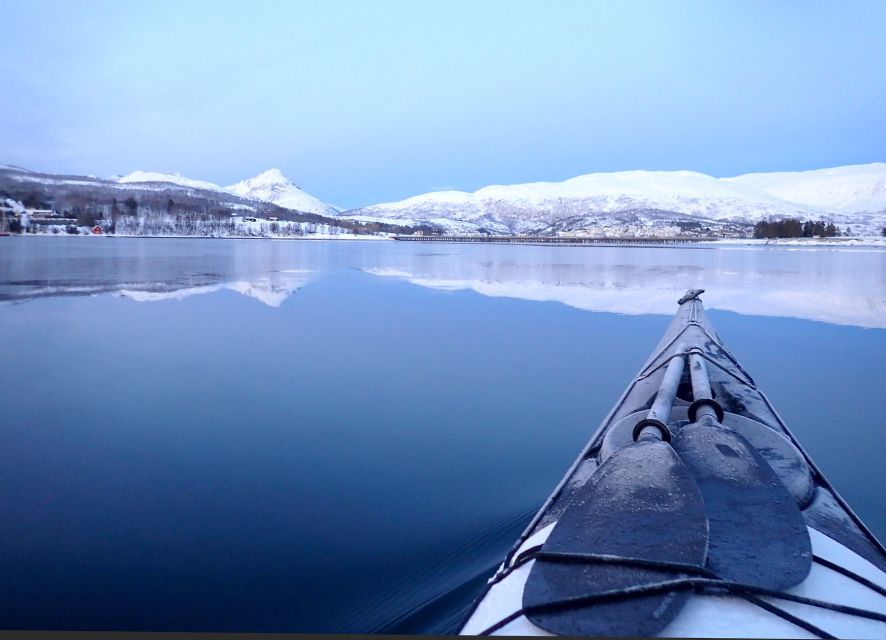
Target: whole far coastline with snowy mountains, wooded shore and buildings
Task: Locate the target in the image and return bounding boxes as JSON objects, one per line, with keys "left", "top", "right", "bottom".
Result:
{"left": 6, "top": 163, "right": 886, "bottom": 239}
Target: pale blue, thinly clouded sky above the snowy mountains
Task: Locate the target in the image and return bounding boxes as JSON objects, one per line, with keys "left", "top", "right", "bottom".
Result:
{"left": 0, "top": 0, "right": 886, "bottom": 208}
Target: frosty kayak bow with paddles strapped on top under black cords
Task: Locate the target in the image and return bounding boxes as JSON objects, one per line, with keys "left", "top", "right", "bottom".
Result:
{"left": 461, "top": 289, "right": 886, "bottom": 637}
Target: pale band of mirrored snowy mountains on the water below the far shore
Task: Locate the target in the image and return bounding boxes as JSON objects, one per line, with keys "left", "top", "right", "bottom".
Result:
{"left": 0, "top": 238, "right": 886, "bottom": 328}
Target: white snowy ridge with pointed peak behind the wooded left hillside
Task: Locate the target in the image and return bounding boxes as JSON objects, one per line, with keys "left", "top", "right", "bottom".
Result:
{"left": 111, "top": 169, "right": 338, "bottom": 216}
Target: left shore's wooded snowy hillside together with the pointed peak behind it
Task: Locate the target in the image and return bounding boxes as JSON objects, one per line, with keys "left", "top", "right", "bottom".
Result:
{"left": 0, "top": 166, "right": 414, "bottom": 237}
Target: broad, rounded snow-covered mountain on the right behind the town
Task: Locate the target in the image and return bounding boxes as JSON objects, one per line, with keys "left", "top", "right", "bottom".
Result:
{"left": 344, "top": 163, "right": 886, "bottom": 234}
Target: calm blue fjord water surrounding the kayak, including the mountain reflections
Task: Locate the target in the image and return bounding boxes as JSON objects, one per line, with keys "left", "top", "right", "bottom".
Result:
{"left": 0, "top": 237, "right": 886, "bottom": 632}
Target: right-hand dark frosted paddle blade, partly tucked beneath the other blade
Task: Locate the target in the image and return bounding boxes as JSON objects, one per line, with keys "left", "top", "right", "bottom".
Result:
{"left": 672, "top": 424, "right": 812, "bottom": 590}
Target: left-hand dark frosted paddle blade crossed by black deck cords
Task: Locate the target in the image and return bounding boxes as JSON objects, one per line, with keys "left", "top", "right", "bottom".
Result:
{"left": 523, "top": 441, "right": 708, "bottom": 636}
